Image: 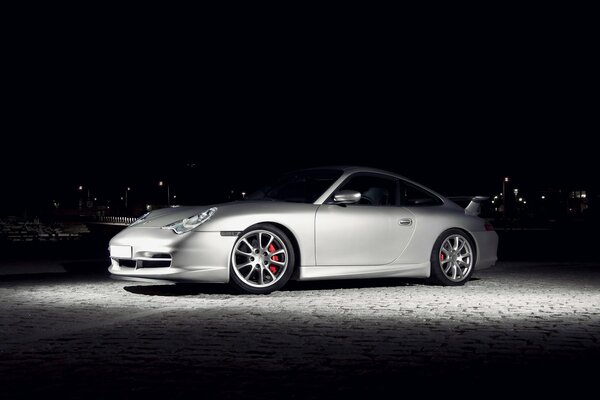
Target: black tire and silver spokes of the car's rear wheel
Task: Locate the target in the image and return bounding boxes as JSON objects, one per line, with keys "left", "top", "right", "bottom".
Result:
{"left": 428, "top": 229, "right": 477, "bottom": 286}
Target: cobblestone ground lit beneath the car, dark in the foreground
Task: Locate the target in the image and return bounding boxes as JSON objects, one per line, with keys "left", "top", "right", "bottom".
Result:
{"left": 0, "top": 262, "right": 600, "bottom": 399}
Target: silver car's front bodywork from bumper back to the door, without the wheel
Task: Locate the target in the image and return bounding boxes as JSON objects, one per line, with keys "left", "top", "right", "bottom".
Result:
{"left": 109, "top": 200, "right": 318, "bottom": 283}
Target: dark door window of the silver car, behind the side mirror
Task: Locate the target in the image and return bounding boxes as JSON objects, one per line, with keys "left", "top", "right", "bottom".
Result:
{"left": 340, "top": 175, "right": 398, "bottom": 206}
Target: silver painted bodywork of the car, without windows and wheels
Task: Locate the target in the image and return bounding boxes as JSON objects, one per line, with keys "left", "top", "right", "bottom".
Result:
{"left": 109, "top": 167, "right": 498, "bottom": 283}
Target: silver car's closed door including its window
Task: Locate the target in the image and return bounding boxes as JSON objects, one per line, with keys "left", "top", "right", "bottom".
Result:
{"left": 315, "top": 173, "right": 416, "bottom": 266}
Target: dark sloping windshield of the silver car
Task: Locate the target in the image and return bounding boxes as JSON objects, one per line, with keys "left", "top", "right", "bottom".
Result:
{"left": 248, "top": 169, "right": 342, "bottom": 203}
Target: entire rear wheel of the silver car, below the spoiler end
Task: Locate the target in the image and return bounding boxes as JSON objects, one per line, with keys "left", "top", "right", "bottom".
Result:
{"left": 429, "top": 229, "right": 475, "bottom": 286}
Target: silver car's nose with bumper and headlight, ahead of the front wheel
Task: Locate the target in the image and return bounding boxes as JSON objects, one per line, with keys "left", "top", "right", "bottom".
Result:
{"left": 109, "top": 207, "right": 236, "bottom": 283}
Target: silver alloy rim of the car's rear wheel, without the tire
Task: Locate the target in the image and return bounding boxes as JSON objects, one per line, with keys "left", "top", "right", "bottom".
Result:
{"left": 439, "top": 235, "right": 473, "bottom": 282}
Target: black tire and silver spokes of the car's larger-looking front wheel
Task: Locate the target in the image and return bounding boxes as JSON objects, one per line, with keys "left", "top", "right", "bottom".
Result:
{"left": 229, "top": 224, "right": 295, "bottom": 294}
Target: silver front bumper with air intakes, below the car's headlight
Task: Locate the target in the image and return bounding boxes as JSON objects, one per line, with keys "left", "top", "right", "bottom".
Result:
{"left": 108, "top": 227, "right": 237, "bottom": 283}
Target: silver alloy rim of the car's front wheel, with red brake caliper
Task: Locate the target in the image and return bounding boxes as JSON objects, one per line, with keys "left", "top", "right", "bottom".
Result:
{"left": 231, "top": 230, "right": 288, "bottom": 288}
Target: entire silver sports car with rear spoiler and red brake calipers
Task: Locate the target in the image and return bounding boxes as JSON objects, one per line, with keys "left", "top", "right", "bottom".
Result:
{"left": 109, "top": 167, "right": 498, "bottom": 294}
